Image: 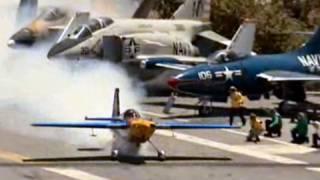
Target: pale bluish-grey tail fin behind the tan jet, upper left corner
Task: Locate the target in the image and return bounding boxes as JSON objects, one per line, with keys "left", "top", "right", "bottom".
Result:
{"left": 16, "top": 0, "right": 38, "bottom": 25}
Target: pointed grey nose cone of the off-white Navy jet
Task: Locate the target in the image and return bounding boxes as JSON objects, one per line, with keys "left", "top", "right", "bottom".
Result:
{"left": 47, "top": 38, "right": 80, "bottom": 58}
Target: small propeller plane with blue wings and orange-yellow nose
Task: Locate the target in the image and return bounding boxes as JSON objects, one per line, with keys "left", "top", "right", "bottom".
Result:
{"left": 32, "top": 89, "right": 239, "bottom": 160}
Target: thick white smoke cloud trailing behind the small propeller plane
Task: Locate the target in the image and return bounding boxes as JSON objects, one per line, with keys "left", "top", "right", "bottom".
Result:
{"left": 0, "top": 1, "right": 144, "bottom": 148}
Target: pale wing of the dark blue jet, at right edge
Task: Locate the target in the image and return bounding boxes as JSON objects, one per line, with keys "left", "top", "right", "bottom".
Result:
{"left": 257, "top": 71, "right": 320, "bottom": 82}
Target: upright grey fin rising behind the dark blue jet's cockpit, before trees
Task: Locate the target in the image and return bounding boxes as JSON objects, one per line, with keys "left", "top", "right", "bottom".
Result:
{"left": 227, "top": 21, "right": 256, "bottom": 57}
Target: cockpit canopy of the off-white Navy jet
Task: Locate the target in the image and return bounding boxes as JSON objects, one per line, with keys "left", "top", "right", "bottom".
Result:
{"left": 72, "top": 17, "right": 113, "bottom": 39}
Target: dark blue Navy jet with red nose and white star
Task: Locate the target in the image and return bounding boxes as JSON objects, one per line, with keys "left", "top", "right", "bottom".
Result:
{"left": 151, "top": 29, "right": 320, "bottom": 110}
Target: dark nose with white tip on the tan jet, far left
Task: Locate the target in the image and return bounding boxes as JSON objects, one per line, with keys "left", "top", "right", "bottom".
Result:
{"left": 8, "top": 28, "right": 36, "bottom": 47}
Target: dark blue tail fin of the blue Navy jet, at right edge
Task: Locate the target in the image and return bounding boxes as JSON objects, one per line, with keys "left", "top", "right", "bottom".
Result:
{"left": 298, "top": 28, "right": 320, "bottom": 54}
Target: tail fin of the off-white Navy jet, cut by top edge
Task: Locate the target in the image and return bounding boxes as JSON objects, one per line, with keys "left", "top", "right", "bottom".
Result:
{"left": 173, "top": 0, "right": 211, "bottom": 21}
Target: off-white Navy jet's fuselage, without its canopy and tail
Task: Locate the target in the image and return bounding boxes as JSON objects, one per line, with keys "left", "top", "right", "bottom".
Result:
{"left": 51, "top": 19, "right": 211, "bottom": 59}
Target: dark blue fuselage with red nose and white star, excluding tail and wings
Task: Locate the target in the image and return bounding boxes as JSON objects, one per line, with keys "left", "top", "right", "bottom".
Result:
{"left": 169, "top": 51, "right": 320, "bottom": 101}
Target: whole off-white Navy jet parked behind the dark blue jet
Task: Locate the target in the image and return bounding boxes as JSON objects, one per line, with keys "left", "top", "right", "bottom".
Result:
{"left": 48, "top": 0, "right": 230, "bottom": 62}
